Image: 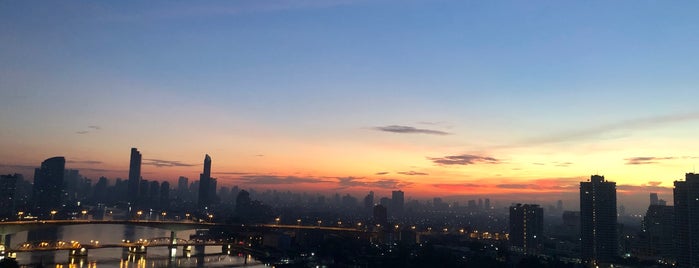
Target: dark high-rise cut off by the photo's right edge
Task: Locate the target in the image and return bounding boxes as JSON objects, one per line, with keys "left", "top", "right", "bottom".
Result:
{"left": 673, "top": 173, "right": 699, "bottom": 267}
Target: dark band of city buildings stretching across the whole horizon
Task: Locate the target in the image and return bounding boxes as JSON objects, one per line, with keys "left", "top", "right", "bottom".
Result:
{"left": 0, "top": 148, "right": 699, "bottom": 267}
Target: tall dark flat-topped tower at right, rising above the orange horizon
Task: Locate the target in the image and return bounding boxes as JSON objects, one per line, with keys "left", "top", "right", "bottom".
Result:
{"left": 580, "top": 175, "right": 618, "bottom": 264}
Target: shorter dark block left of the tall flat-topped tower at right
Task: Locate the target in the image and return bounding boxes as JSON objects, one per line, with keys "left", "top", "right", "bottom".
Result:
{"left": 510, "top": 204, "right": 544, "bottom": 254}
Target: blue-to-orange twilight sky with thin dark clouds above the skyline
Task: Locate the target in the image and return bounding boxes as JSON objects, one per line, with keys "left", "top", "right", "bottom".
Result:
{"left": 0, "top": 0, "right": 699, "bottom": 213}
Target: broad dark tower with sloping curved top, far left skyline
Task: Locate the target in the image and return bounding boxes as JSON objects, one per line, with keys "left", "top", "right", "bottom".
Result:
{"left": 32, "top": 156, "right": 66, "bottom": 216}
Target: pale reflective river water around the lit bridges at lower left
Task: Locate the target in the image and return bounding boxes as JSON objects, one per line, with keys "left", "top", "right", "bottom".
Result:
{"left": 10, "top": 224, "right": 265, "bottom": 268}
